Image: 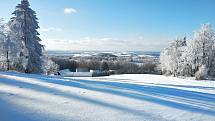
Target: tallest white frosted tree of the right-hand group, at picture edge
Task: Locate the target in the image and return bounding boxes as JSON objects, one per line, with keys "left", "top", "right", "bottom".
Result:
{"left": 190, "top": 24, "right": 215, "bottom": 75}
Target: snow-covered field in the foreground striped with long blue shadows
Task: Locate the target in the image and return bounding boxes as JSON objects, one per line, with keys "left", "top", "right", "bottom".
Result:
{"left": 0, "top": 72, "right": 215, "bottom": 121}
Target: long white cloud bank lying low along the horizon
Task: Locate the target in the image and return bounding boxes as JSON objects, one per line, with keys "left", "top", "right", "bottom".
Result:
{"left": 42, "top": 37, "right": 168, "bottom": 51}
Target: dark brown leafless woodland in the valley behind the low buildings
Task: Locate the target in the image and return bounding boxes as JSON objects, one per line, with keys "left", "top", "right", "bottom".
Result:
{"left": 52, "top": 57, "right": 160, "bottom": 74}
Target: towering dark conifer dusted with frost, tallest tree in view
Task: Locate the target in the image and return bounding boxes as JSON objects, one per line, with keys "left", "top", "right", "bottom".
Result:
{"left": 8, "top": 0, "right": 44, "bottom": 73}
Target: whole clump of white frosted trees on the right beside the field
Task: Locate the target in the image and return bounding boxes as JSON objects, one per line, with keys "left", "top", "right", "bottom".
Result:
{"left": 160, "top": 24, "right": 215, "bottom": 79}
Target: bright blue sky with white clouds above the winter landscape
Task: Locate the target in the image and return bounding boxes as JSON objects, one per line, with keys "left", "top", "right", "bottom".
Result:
{"left": 0, "top": 0, "right": 215, "bottom": 51}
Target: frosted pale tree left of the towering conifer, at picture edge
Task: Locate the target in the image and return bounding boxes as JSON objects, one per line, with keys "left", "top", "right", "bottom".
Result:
{"left": 0, "top": 18, "right": 29, "bottom": 72}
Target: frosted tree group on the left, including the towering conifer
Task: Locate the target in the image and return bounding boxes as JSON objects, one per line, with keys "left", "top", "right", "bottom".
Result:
{"left": 0, "top": 0, "right": 57, "bottom": 74}
